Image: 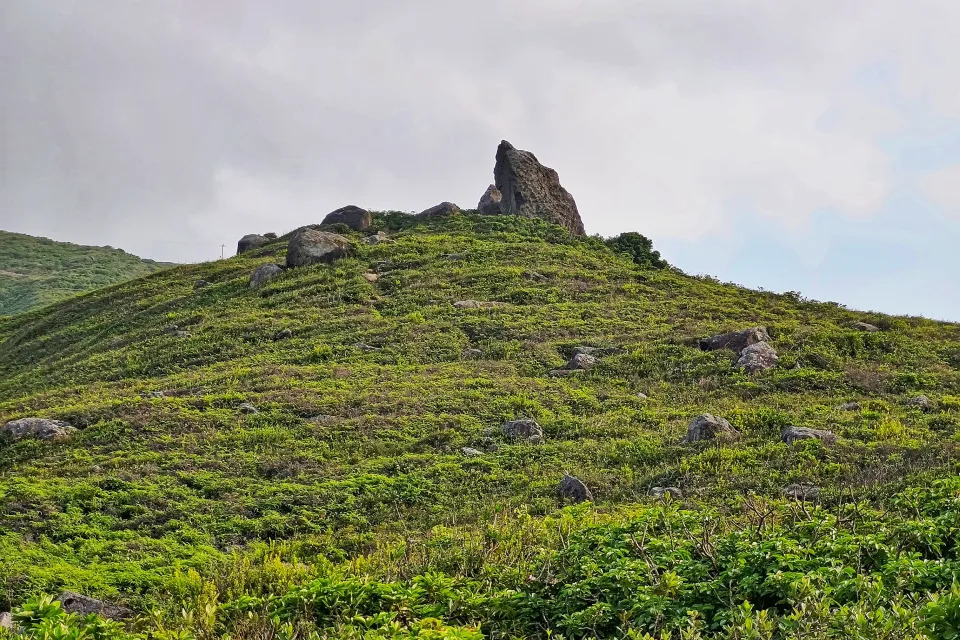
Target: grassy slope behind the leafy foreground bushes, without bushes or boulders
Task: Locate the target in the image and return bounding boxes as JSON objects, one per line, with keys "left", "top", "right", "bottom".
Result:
{"left": 0, "top": 216, "right": 960, "bottom": 637}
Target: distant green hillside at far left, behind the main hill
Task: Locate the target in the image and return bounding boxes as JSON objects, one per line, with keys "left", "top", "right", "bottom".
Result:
{"left": 0, "top": 231, "right": 170, "bottom": 316}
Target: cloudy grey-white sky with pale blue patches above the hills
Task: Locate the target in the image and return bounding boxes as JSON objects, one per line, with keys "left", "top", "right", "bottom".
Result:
{"left": 0, "top": 0, "right": 960, "bottom": 320}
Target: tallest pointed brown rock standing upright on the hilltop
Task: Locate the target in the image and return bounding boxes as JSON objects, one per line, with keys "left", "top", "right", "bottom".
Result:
{"left": 496, "top": 140, "right": 586, "bottom": 236}
